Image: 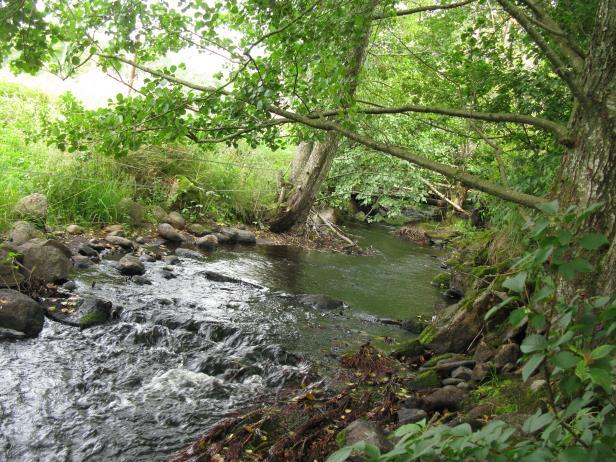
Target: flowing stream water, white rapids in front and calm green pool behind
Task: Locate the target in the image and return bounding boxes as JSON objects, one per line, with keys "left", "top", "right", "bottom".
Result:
{"left": 0, "top": 222, "right": 439, "bottom": 462}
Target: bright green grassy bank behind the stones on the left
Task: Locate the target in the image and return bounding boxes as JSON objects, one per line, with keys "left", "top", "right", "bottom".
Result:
{"left": 0, "top": 83, "right": 291, "bottom": 231}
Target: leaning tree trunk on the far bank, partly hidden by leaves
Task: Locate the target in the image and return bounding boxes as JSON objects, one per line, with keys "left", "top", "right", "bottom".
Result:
{"left": 270, "top": 0, "right": 379, "bottom": 233}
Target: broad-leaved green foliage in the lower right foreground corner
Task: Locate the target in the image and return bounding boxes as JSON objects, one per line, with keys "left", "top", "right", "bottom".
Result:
{"left": 328, "top": 203, "right": 616, "bottom": 462}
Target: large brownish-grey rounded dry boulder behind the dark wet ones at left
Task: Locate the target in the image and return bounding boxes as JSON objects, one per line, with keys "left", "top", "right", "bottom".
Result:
{"left": 20, "top": 239, "right": 73, "bottom": 282}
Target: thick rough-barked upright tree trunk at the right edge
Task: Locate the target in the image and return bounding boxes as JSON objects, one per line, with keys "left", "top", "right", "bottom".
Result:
{"left": 557, "top": 1, "right": 616, "bottom": 295}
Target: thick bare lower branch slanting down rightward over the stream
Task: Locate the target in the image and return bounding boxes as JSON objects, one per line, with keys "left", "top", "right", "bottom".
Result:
{"left": 269, "top": 107, "right": 547, "bottom": 208}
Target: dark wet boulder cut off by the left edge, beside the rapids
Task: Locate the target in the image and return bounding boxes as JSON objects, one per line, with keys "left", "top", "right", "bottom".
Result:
{"left": 0, "top": 289, "right": 45, "bottom": 337}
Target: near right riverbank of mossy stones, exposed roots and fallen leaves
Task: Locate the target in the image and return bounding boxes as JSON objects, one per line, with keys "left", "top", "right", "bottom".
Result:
{"left": 173, "top": 227, "right": 546, "bottom": 462}
